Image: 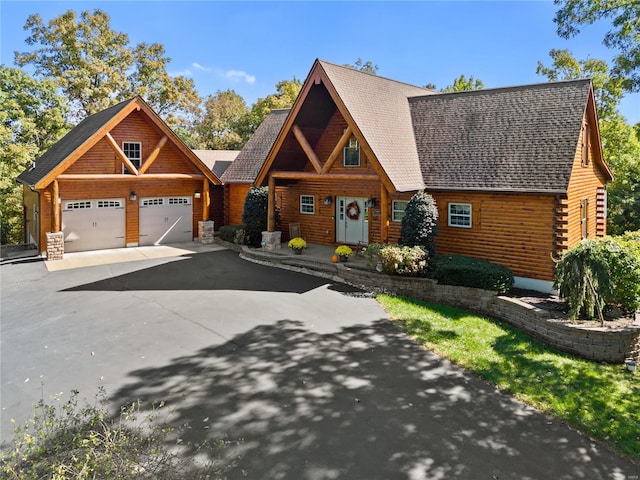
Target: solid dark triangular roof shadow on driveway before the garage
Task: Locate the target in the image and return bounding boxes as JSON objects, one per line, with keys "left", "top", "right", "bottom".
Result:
{"left": 62, "top": 250, "right": 361, "bottom": 294}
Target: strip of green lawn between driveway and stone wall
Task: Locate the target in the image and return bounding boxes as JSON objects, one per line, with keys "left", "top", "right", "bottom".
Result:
{"left": 377, "top": 295, "right": 640, "bottom": 460}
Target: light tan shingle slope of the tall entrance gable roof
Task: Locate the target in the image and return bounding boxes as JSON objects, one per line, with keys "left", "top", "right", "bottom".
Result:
{"left": 319, "top": 60, "right": 433, "bottom": 191}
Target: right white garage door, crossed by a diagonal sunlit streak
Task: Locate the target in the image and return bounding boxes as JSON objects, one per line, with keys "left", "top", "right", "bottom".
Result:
{"left": 139, "top": 197, "right": 193, "bottom": 245}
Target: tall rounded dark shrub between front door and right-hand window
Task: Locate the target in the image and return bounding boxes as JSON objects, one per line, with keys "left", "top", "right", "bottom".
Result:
{"left": 399, "top": 191, "right": 438, "bottom": 256}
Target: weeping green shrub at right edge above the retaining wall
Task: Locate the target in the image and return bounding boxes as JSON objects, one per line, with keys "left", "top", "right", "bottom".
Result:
{"left": 554, "top": 232, "right": 640, "bottom": 319}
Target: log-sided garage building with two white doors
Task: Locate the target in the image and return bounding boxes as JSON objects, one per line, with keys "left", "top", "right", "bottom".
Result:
{"left": 18, "top": 97, "right": 222, "bottom": 254}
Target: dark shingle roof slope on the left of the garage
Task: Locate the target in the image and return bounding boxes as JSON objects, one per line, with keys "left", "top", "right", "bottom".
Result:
{"left": 17, "top": 98, "right": 136, "bottom": 188}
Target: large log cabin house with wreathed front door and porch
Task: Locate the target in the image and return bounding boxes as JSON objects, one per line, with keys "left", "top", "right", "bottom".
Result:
{"left": 223, "top": 60, "right": 612, "bottom": 291}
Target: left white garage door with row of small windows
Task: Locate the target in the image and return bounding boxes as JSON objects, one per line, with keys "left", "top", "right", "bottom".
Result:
{"left": 62, "top": 198, "right": 126, "bottom": 252}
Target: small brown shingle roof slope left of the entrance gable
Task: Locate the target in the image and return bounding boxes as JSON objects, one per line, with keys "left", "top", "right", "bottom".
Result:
{"left": 220, "top": 108, "right": 289, "bottom": 183}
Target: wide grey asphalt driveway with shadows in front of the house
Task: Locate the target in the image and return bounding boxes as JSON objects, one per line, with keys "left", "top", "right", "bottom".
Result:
{"left": 0, "top": 250, "right": 640, "bottom": 480}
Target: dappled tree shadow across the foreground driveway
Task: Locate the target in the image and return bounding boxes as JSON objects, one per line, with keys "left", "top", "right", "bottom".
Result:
{"left": 112, "top": 320, "right": 638, "bottom": 480}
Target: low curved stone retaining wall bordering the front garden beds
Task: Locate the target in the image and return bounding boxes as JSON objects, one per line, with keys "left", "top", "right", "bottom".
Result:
{"left": 230, "top": 240, "right": 640, "bottom": 363}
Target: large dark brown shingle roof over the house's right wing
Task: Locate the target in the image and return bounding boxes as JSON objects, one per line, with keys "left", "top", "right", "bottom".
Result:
{"left": 409, "top": 80, "right": 591, "bottom": 192}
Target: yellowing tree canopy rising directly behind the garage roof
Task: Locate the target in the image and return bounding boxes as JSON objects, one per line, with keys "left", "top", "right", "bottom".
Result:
{"left": 15, "top": 9, "right": 200, "bottom": 124}
